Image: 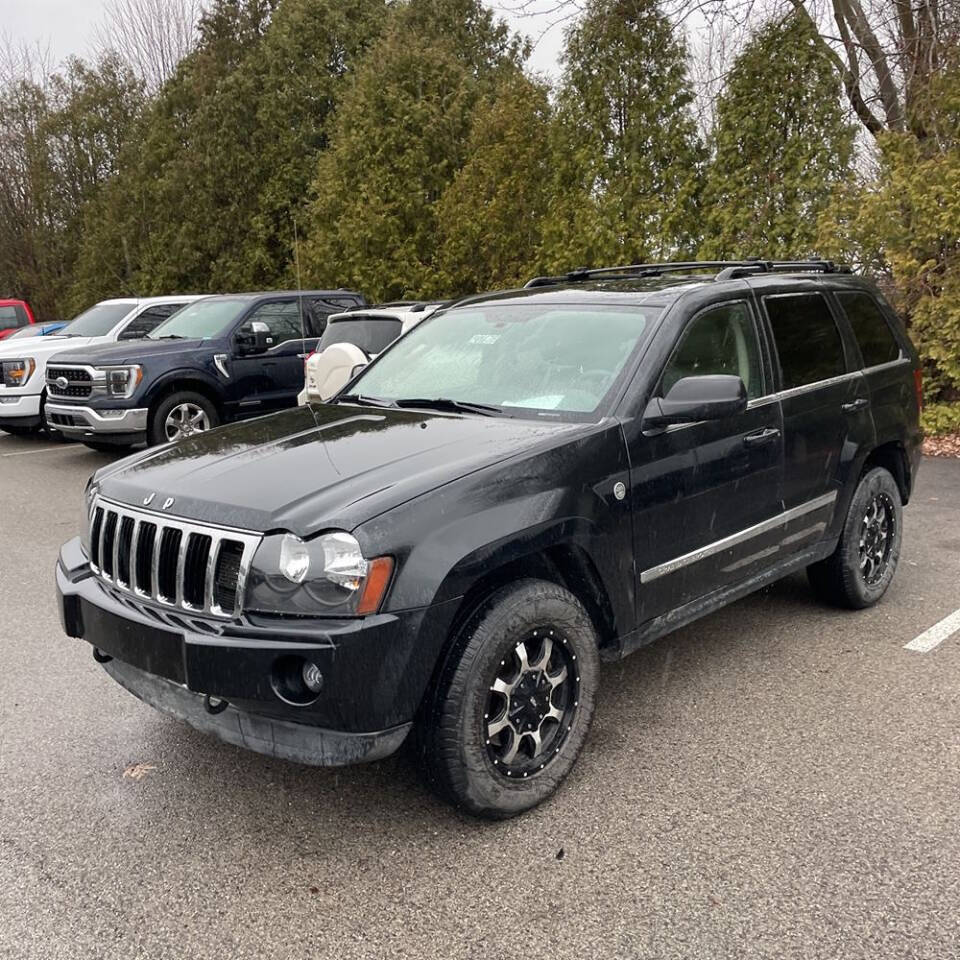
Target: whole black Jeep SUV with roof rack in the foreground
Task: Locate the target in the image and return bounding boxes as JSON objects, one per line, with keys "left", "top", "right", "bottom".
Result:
{"left": 57, "top": 261, "right": 920, "bottom": 817}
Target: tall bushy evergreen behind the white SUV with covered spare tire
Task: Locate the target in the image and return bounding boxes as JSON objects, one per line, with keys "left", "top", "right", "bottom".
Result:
{"left": 303, "top": 0, "right": 519, "bottom": 299}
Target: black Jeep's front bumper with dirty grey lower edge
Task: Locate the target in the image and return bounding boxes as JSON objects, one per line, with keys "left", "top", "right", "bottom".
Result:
{"left": 56, "top": 539, "right": 455, "bottom": 765}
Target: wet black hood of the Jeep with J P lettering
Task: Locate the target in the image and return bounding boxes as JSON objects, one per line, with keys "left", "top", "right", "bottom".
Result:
{"left": 95, "top": 404, "right": 595, "bottom": 537}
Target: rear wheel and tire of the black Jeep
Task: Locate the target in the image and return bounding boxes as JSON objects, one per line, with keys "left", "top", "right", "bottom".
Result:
{"left": 807, "top": 467, "right": 903, "bottom": 610}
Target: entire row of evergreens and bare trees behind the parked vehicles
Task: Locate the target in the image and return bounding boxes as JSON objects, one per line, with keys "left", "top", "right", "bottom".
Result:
{"left": 0, "top": 0, "right": 960, "bottom": 426}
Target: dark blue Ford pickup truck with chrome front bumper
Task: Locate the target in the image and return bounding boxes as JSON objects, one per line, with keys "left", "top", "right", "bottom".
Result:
{"left": 46, "top": 290, "right": 365, "bottom": 450}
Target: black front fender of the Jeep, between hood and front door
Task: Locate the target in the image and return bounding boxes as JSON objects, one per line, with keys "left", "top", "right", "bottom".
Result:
{"left": 355, "top": 427, "right": 635, "bottom": 633}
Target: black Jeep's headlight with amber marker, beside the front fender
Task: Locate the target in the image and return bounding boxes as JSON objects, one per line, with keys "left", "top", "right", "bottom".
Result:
{"left": 251, "top": 532, "right": 393, "bottom": 616}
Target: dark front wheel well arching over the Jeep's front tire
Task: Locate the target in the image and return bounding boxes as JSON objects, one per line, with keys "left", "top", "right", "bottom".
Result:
{"left": 450, "top": 545, "right": 616, "bottom": 647}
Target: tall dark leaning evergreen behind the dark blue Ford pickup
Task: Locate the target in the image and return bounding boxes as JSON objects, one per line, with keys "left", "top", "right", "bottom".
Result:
{"left": 74, "top": 0, "right": 384, "bottom": 301}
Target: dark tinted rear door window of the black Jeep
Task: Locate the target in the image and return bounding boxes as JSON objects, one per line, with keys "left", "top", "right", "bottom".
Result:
{"left": 763, "top": 293, "right": 847, "bottom": 390}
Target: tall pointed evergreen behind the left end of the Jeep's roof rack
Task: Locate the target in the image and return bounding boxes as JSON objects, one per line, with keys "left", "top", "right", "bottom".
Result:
{"left": 544, "top": 0, "right": 702, "bottom": 269}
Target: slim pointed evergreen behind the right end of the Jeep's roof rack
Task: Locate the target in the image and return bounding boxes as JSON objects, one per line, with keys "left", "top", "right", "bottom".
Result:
{"left": 702, "top": 15, "right": 854, "bottom": 259}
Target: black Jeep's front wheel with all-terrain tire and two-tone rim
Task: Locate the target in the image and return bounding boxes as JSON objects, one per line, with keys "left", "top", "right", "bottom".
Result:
{"left": 416, "top": 580, "right": 600, "bottom": 820}
